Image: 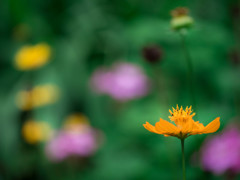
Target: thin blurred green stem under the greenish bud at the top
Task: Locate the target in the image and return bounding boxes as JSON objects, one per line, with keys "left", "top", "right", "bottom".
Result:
{"left": 179, "top": 32, "right": 196, "bottom": 108}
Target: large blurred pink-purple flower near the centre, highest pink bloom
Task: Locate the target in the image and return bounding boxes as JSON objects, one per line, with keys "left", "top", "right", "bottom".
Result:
{"left": 91, "top": 62, "right": 150, "bottom": 101}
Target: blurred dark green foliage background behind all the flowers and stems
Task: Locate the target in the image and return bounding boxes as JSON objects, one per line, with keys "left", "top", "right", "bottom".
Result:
{"left": 0, "top": 0, "right": 240, "bottom": 180}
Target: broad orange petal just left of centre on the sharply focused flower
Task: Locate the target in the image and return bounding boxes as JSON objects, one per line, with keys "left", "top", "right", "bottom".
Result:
{"left": 155, "top": 119, "right": 179, "bottom": 135}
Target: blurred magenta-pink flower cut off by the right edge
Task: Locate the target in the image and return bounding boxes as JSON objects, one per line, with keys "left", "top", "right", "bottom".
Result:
{"left": 201, "top": 127, "right": 240, "bottom": 175}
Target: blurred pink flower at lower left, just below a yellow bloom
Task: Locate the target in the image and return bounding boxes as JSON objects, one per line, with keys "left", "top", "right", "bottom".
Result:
{"left": 46, "top": 127, "right": 97, "bottom": 161}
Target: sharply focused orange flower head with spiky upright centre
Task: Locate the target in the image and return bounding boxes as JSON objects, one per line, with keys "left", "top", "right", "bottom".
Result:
{"left": 143, "top": 105, "right": 220, "bottom": 139}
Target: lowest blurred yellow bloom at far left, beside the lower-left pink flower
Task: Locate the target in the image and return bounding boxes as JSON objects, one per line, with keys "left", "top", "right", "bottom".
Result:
{"left": 22, "top": 120, "right": 51, "bottom": 144}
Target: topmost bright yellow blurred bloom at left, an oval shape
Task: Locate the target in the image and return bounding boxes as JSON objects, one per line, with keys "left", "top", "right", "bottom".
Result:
{"left": 15, "top": 43, "right": 51, "bottom": 71}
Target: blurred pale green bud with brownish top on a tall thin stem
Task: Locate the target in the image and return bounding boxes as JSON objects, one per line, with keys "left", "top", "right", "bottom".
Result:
{"left": 171, "top": 7, "right": 194, "bottom": 30}
